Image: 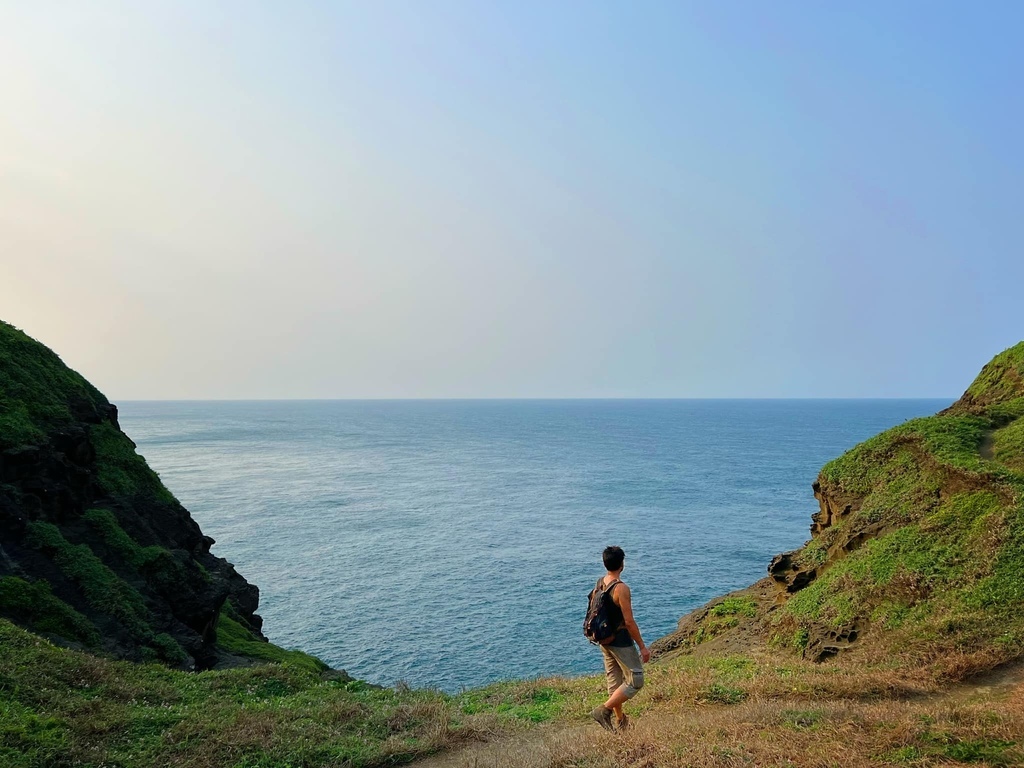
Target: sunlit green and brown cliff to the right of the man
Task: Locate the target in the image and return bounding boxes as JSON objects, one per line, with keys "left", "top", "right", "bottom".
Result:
{"left": 655, "top": 342, "right": 1024, "bottom": 677}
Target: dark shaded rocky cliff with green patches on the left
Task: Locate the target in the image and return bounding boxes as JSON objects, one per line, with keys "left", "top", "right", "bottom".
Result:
{"left": 0, "top": 323, "right": 262, "bottom": 669}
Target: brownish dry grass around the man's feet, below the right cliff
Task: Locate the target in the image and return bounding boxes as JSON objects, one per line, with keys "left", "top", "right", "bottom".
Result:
{"left": 423, "top": 652, "right": 1024, "bottom": 768}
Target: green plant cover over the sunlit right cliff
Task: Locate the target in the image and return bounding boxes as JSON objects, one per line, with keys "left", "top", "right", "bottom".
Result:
{"left": 773, "top": 358, "right": 1024, "bottom": 655}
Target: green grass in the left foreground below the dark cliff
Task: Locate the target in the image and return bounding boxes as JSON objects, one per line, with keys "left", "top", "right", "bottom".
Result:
{"left": 0, "top": 620, "right": 487, "bottom": 768}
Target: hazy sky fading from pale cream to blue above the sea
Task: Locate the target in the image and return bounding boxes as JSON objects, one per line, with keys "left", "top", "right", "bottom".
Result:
{"left": 0, "top": 0, "right": 1024, "bottom": 401}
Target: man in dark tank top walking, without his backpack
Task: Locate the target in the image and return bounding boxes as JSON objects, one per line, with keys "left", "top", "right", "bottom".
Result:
{"left": 591, "top": 547, "right": 650, "bottom": 731}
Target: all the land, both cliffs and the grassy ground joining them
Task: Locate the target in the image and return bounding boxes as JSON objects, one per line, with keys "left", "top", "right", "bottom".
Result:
{"left": 0, "top": 323, "right": 1024, "bottom": 768}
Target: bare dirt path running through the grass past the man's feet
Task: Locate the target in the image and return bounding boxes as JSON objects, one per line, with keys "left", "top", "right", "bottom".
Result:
{"left": 413, "top": 663, "right": 1024, "bottom": 768}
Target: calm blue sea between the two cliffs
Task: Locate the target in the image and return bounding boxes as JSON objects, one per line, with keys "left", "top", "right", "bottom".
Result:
{"left": 121, "top": 400, "right": 948, "bottom": 690}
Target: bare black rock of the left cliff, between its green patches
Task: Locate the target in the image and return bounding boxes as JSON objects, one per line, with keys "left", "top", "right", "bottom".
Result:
{"left": 0, "top": 402, "right": 262, "bottom": 669}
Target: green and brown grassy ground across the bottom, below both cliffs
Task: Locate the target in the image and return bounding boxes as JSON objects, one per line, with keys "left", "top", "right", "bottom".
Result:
{"left": 0, "top": 621, "right": 1024, "bottom": 768}
